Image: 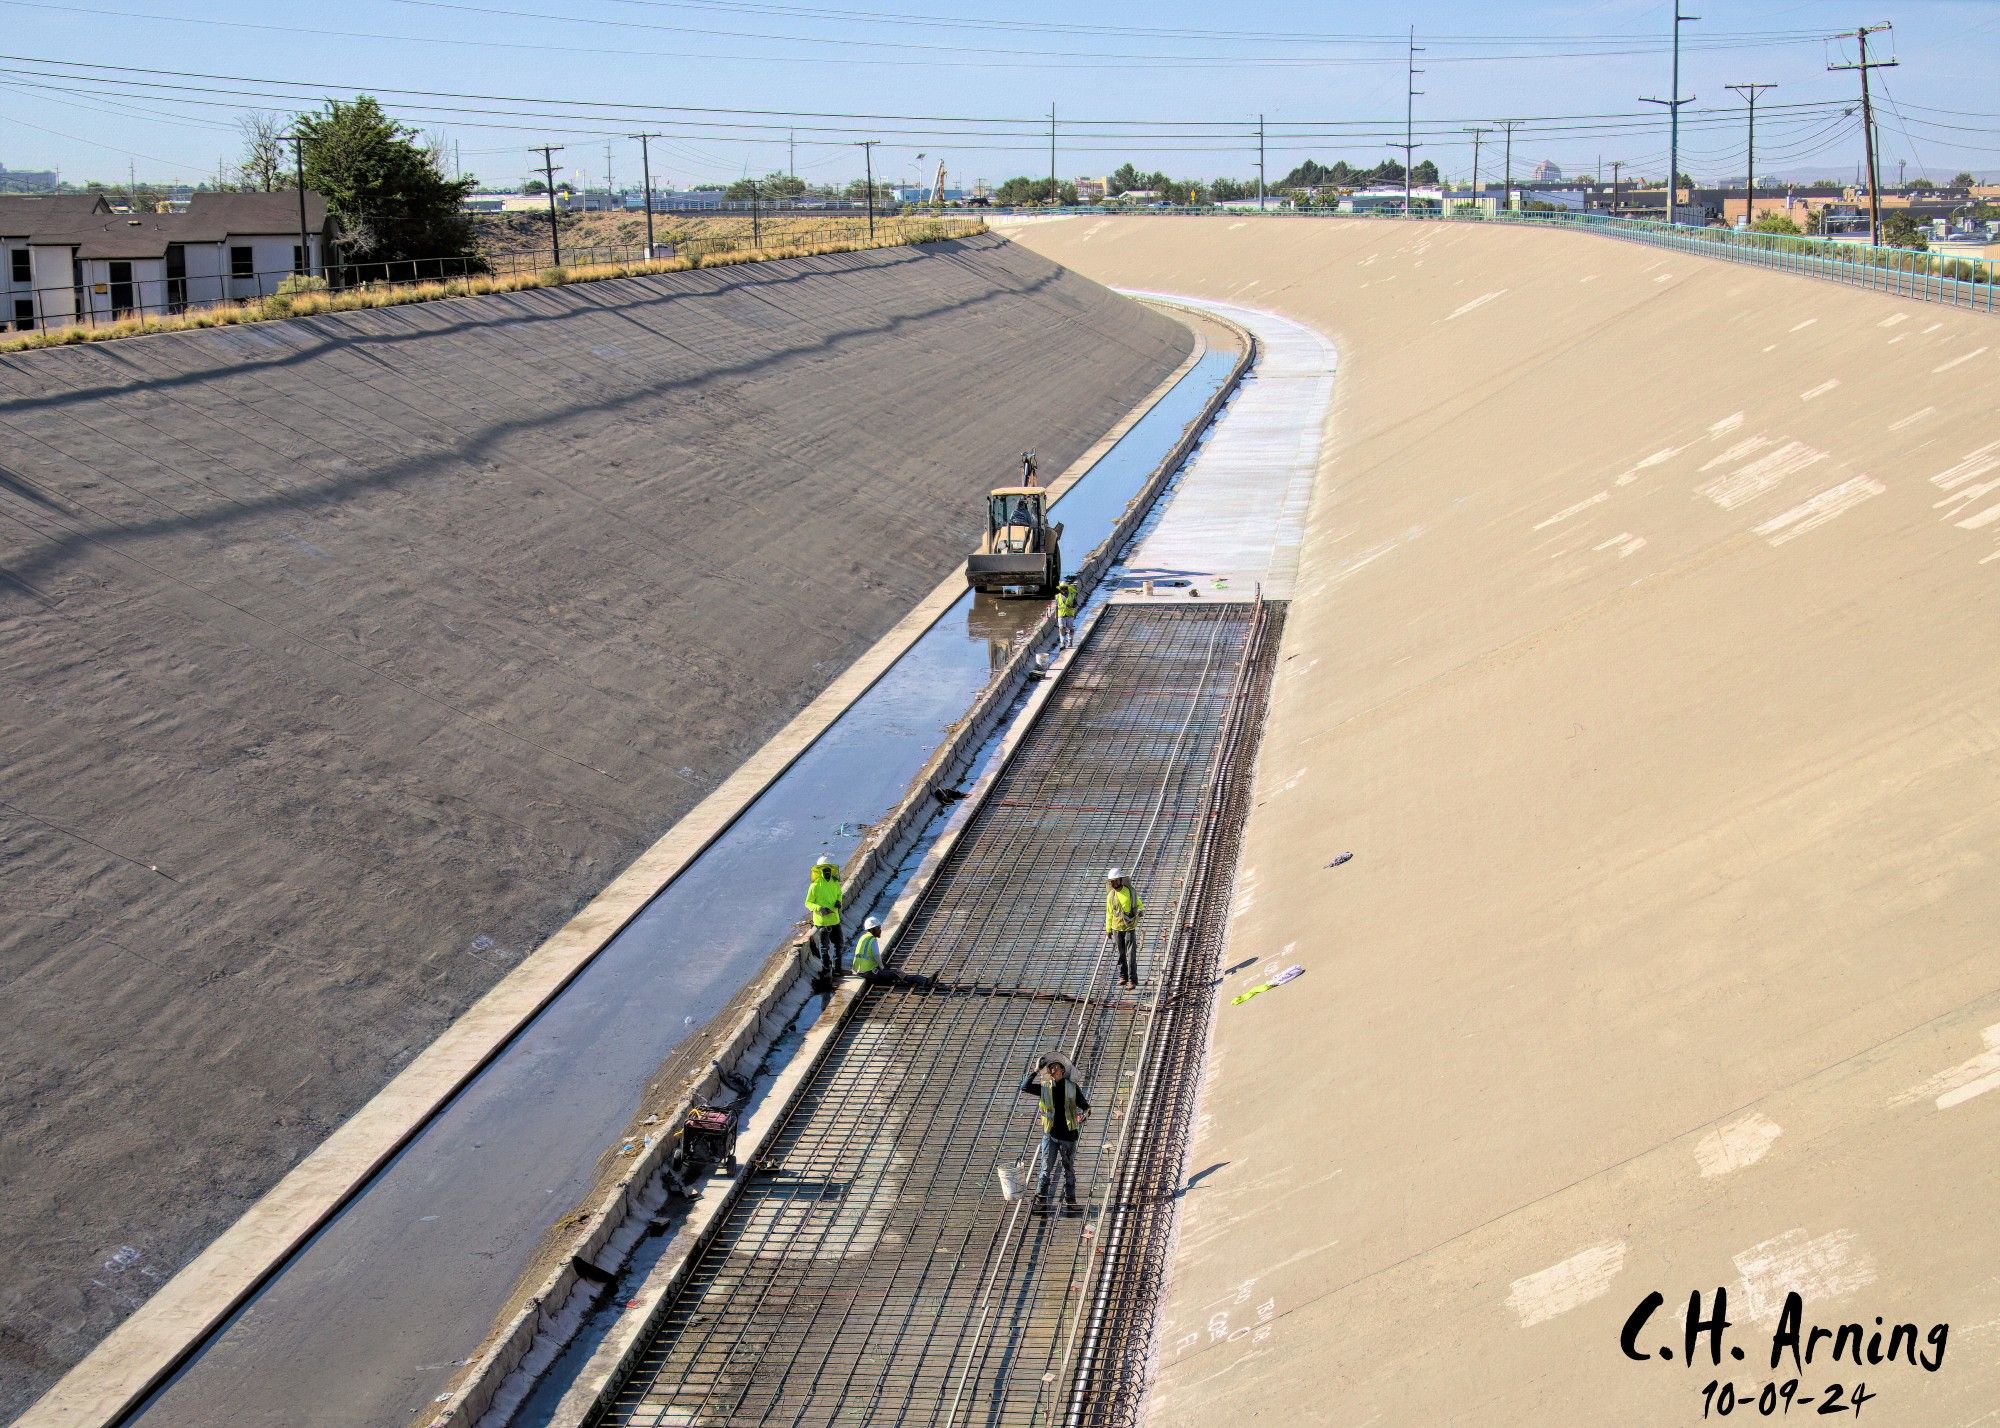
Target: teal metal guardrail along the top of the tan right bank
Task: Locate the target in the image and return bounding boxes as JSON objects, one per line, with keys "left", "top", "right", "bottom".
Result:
{"left": 992, "top": 206, "right": 2000, "bottom": 312}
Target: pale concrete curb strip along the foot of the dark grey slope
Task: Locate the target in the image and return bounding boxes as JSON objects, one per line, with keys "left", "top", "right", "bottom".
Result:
{"left": 16, "top": 312, "right": 1204, "bottom": 1428}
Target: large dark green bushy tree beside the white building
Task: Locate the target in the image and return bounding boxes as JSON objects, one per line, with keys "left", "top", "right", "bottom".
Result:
{"left": 296, "top": 94, "right": 478, "bottom": 262}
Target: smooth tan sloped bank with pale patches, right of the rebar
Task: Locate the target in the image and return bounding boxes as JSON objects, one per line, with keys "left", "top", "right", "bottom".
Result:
{"left": 1020, "top": 218, "right": 2000, "bottom": 1428}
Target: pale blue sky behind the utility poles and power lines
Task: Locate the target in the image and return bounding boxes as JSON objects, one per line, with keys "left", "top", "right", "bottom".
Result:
{"left": 0, "top": 0, "right": 2000, "bottom": 184}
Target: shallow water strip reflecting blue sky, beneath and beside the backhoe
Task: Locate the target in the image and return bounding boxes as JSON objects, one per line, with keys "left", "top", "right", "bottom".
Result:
{"left": 128, "top": 352, "right": 1236, "bottom": 1428}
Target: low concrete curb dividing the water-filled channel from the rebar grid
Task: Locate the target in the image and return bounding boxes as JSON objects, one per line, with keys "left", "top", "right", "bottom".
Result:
{"left": 446, "top": 304, "right": 1256, "bottom": 1428}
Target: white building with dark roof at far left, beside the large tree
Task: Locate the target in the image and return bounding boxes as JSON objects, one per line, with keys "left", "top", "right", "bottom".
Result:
{"left": 0, "top": 190, "right": 332, "bottom": 328}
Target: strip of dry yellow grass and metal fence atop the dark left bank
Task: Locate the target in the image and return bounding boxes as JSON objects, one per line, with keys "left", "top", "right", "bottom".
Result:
{"left": 0, "top": 212, "right": 978, "bottom": 334}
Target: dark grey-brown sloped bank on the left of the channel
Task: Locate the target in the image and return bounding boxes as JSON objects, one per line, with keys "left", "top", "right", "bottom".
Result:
{"left": 0, "top": 238, "right": 1190, "bottom": 1418}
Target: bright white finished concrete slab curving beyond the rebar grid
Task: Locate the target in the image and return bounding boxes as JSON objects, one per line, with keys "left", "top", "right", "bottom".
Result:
{"left": 1124, "top": 292, "right": 1338, "bottom": 600}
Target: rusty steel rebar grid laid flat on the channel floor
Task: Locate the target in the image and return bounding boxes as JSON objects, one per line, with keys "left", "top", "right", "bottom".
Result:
{"left": 596, "top": 604, "right": 1270, "bottom": 1428}
